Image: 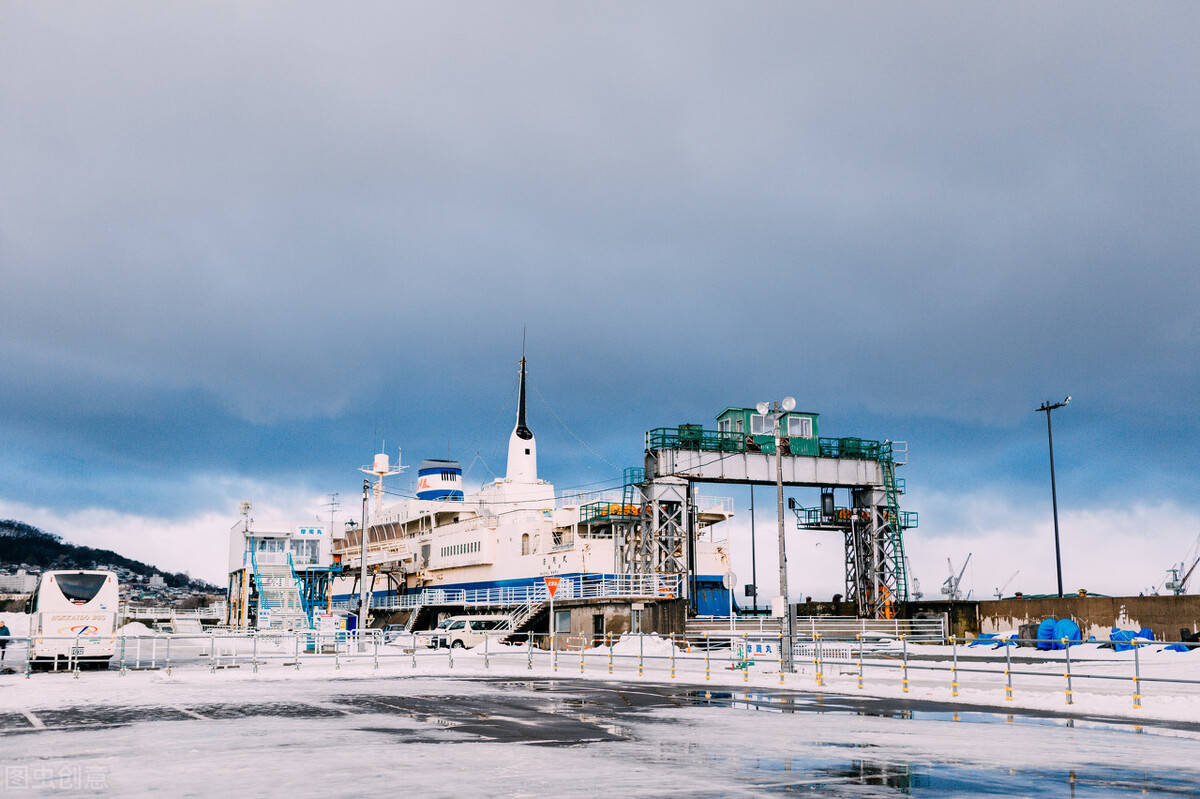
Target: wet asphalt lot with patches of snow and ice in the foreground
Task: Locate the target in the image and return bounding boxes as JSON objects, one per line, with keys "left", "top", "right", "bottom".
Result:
{"left": 0, "top": 666, "right": 1200, "bottom": 797}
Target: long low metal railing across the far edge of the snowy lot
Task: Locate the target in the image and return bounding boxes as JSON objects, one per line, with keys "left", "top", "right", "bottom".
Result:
{"left": 7, "top": 630, "right": 1200, "bottom": 709}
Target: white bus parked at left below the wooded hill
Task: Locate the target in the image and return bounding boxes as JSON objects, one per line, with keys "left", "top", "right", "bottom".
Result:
{"left": 28, "top": 570, "right": 118, "bottom": 668}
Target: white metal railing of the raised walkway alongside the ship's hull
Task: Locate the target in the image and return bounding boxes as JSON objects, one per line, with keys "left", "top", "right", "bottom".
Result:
{"left": 350, "top": 575, "right": 683, "bottom": 611}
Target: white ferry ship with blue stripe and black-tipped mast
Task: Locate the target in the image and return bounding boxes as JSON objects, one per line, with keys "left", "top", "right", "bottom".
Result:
{"left": 331, "top": 358, "right": 733, "bottom": 615}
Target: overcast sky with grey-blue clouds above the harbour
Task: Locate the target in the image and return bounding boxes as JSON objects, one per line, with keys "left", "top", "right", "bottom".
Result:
{"left": 0, "top": 0, "right": 1200, "bottom": 596}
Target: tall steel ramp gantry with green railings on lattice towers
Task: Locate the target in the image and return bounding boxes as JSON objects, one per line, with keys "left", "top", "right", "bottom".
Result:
{"left": 593, "top": 422, "right": 917, "bottom": 618}
